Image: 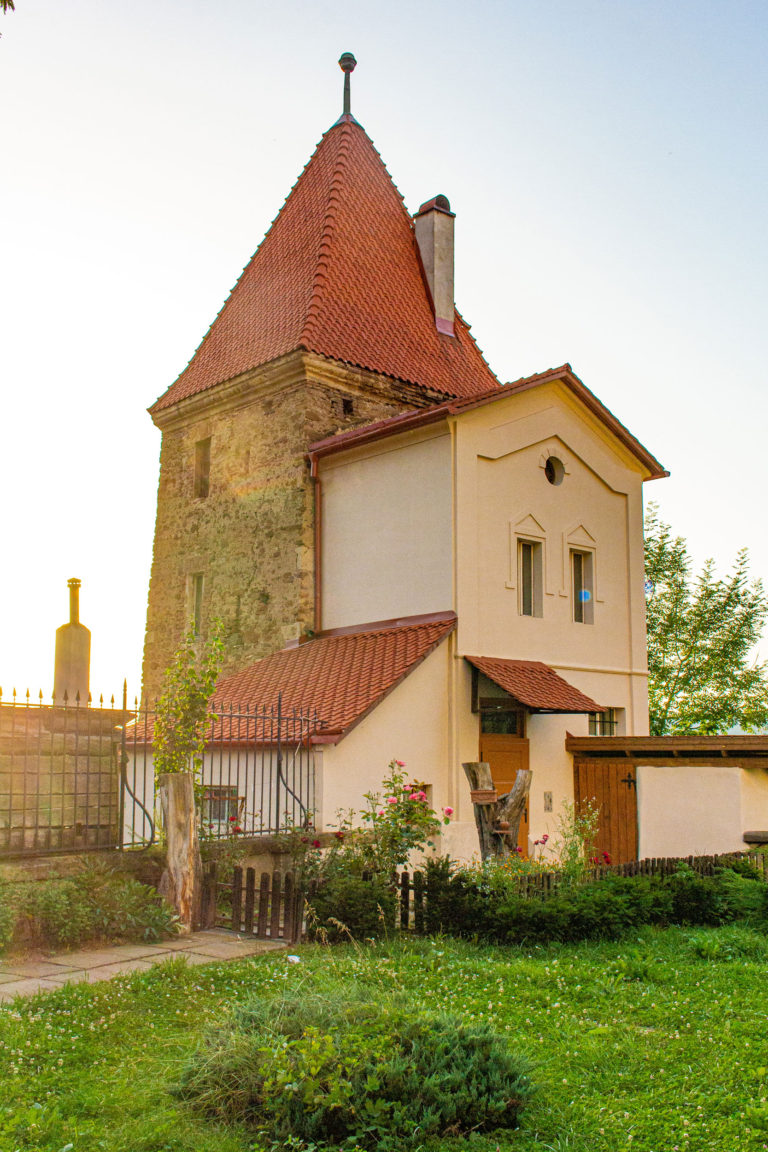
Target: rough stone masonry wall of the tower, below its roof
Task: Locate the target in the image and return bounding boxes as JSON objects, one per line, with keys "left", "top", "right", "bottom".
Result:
{"left": 143, "top": 365, "right": 433, "bottom": 699}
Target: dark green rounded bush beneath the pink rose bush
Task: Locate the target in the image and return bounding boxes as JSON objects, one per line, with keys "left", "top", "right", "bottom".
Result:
{"left": 309, "top": 869, "right": 397, "bottom": 942}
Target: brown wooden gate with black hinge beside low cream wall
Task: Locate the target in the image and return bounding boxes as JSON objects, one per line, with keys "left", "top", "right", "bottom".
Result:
{"left": 573, "top": 757, "right": 638, "bottom": 864}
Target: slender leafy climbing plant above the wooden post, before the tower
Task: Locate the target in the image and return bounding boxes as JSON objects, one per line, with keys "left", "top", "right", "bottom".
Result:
{"left": 154, "top": 621, "right": 223, "bottom": 776}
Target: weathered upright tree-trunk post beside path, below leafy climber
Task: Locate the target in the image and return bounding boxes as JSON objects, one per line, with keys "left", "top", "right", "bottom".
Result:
{"left": 158, "top": 772, "right": 203, "bottom": 933}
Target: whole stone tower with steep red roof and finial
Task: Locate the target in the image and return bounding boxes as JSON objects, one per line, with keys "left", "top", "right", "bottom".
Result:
{"left": 143, "top": 54, "right": 499, "bottom": 698}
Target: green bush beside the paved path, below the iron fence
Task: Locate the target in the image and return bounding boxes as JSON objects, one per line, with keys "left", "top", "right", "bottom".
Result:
{"left": 0, "top": 863, "right": 176, "bottom": 948}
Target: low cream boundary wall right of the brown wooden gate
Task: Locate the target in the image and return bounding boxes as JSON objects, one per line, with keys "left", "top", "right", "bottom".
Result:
{"left": 637, "top": 764, "right": 750, "bottom": 859}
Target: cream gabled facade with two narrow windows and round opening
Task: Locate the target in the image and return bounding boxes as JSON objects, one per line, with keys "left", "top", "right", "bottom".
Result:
{"left": 454, "top": 384, "right": 647, "bottom": 735}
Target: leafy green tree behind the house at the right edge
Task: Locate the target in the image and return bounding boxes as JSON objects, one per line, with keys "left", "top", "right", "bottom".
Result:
{"left": 645, "top": 505, "right": 768, "bottom": 736}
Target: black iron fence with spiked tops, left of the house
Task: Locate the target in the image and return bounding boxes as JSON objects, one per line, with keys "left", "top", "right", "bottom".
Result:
{"left": 0, "top": 684, "right": 319, "bottom": 856}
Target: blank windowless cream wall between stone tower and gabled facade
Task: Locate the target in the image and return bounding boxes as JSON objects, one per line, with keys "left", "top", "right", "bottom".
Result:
{"left": 320, "top": 425, "right": 453, "bottom": 628}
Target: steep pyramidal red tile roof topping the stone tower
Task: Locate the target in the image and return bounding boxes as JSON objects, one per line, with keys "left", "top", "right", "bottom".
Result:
{"left": 151, "top": 116, "right": 500, "bottom": 411}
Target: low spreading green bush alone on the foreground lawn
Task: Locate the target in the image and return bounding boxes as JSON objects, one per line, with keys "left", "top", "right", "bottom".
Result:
{"left": 177, "top": 995, "right": 531, "bottom": 1152}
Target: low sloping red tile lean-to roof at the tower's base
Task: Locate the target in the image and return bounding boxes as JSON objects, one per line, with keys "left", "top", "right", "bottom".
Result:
{"left": 214, "top": 612, "right": 456, "bottom": 743}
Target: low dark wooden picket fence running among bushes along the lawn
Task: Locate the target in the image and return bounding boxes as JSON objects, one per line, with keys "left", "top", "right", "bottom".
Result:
{"left": 200, "top": 852, "right": 768, "bottom": 943}
